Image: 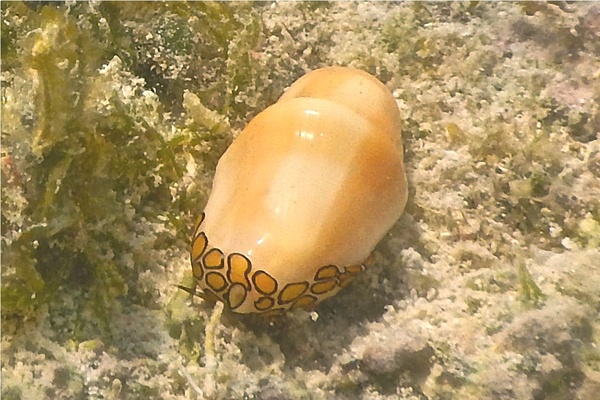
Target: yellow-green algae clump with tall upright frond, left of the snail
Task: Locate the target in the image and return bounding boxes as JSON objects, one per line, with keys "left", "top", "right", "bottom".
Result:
{"left": 2, "top": 7, "right": 168, "bottom": 326}
